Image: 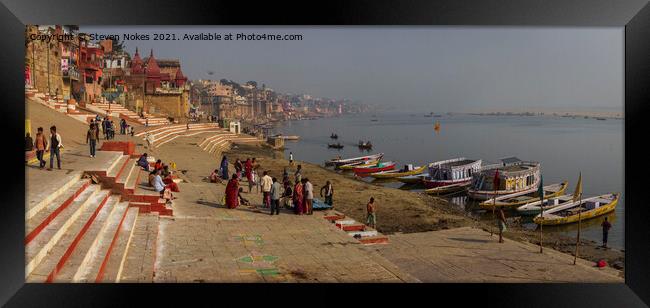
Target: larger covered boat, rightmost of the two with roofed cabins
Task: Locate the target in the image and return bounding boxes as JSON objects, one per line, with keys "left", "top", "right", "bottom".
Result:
{"left": 467, "top": 157, "right": 540, "bottom": 201}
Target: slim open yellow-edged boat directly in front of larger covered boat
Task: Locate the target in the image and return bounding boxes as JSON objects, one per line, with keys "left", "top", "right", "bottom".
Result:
{"left": 479, "top": 181, "right": 569, "bottom": 210}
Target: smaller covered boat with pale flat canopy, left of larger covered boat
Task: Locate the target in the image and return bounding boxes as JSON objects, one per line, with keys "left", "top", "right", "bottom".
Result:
{"left": 422, "top": 157, "right": 481, "bottom": 188}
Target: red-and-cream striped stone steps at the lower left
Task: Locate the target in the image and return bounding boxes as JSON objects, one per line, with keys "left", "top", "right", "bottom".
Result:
{"left": 25, "top": 152, "right": 173, "bottom": 282}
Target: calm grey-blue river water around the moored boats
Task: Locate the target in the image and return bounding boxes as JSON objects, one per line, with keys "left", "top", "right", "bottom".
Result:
{"left": 274, "top": 114, "right": 625, "bottom": 249}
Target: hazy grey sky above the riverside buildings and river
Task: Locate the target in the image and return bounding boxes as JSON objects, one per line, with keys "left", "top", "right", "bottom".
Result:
{"left": 80, "top": 26, "right": 624, "bottom": 112}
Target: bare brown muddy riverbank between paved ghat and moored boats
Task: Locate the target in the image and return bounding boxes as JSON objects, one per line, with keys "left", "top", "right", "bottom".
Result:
{"left": 224, "top": 145, "right": 625, "bottom": 276}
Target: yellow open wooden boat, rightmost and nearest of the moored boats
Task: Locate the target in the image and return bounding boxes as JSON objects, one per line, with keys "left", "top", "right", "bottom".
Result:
{"left": 533, "top": 193, "right": 620, "bottom": 226}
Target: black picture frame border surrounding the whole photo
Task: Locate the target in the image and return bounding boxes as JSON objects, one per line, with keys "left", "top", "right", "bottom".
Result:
{"left": 0, "top": 0, "right": 650, "bottom": 307}
